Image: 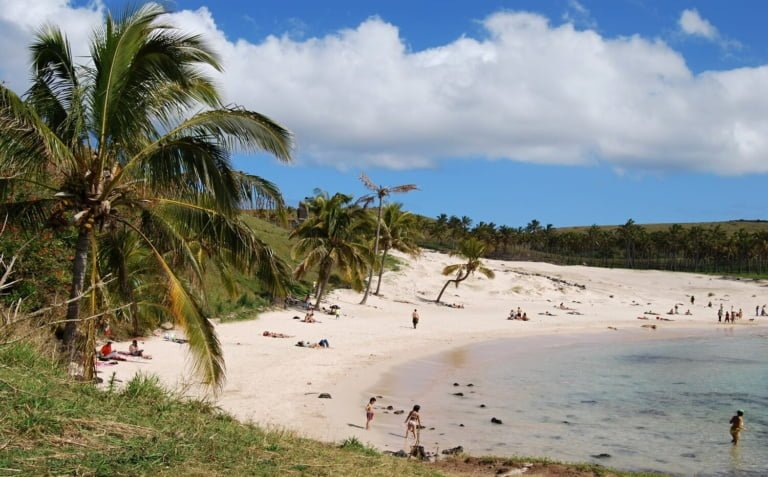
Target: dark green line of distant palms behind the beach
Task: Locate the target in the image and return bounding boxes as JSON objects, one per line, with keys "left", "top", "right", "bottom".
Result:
{"left": 421, "top": 214, "right": 768, "bottom": 275}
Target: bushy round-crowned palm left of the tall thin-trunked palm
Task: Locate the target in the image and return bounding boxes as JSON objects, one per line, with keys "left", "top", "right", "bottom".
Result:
{"left": 289, "top": 193, "right": 370, "bottom": 304}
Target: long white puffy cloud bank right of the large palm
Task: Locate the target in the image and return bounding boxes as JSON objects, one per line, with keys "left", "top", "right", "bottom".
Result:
{"left": 0, "top": 0, "right": 768, "bottom": 174}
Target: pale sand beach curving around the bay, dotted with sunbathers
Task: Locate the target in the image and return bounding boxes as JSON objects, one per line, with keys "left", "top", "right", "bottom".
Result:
{"left": 99, "top": 251, "right": 768, "bottom": 449}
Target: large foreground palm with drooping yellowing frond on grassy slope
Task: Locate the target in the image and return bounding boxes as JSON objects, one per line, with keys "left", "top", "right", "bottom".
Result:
{"left": 0, "top": 4, "right": 291, "bottom": 385}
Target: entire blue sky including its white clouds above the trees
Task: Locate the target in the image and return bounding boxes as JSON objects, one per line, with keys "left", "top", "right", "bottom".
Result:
{"left": 0, "top": 0, "right": 768, "bottom": 226}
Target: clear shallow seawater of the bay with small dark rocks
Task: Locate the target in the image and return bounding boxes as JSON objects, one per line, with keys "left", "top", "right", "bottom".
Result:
{"left": 371, "top": 325, "right": 768, "bottom": 476}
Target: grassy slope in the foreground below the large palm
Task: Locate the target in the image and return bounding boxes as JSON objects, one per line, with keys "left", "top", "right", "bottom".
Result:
{"left": 0, "top": 345, "right": 660, "bottom": 477}
